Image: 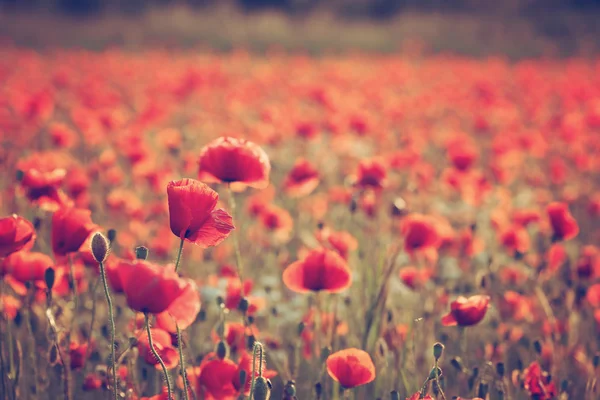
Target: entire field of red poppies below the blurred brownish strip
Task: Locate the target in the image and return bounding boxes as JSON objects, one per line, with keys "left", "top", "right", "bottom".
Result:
{"left": 0, "top": 46, "right": 600, "bottom": 400}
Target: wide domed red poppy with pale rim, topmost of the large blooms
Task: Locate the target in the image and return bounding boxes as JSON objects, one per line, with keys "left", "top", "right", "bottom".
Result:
{"left": 198, "top": 137, "right": 271, "bottom": 189}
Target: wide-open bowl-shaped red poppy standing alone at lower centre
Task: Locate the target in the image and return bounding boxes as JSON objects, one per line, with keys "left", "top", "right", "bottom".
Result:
{"left": 283, "top": 249, "right": 351, "bottom": 293}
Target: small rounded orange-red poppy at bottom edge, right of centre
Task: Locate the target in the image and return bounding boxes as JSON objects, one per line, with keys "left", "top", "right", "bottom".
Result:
{"left": 326, "top": 348, "right": 375, "bottom": 389}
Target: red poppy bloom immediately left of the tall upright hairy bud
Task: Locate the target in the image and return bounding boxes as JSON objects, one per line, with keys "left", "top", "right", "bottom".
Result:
{"left": 52, "top": 207, "right": 97, "bottom": 256}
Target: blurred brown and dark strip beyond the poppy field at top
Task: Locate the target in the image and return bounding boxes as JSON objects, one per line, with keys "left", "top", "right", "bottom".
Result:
{"left": 0, "top": 0, "right": 600, "bottom": 58}
